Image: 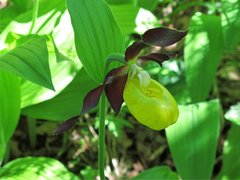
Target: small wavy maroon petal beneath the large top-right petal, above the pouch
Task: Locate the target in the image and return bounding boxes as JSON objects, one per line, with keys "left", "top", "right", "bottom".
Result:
{"left": 138, "top": 53, "right": 169, "bottom": 65}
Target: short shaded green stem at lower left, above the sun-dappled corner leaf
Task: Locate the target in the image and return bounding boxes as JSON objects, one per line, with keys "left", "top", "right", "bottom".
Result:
{"left": 27, "top": 117, "right": 37, "bottom": 149}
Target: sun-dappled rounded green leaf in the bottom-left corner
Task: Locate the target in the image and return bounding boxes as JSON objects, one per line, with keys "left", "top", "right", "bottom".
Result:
{"left": 0, "top": 157, "right": 79, "bottom": 180}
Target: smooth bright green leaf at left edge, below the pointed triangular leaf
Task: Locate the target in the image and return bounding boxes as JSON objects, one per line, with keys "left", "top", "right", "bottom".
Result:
{"left": 0, "top": 70, "right": 20, "bottom": 165}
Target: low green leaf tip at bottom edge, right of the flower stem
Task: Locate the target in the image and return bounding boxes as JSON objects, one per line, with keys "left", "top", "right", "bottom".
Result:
{"left": 132, "top": 166, "right": 179, "bottom": 180}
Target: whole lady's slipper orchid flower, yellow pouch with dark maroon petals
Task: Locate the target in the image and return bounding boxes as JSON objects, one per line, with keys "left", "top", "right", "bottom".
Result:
{"left": 56, "top": 28, "right": 187, "bottom": 133}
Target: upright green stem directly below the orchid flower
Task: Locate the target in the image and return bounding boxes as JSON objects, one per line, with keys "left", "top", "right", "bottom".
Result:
{"left": 98, "top": 93, "right": 106, "bottom": 180}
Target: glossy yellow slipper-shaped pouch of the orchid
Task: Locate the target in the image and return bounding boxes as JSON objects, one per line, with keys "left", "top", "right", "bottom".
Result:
{"left": 123, "top": 78, "right": 179, "bottom": 130}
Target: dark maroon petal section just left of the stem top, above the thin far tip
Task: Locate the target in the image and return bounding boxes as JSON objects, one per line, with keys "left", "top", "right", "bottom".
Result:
{"left": 81, "top": 85, "right": 104, "bottom": 114}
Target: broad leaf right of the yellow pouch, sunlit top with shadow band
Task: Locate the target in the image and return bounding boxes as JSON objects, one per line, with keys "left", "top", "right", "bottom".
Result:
{"left": 166, "top": 100, "right": 220, "bottom": 179}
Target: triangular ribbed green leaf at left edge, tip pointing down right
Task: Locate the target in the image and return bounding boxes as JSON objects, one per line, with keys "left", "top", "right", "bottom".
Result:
{"left": 0, "top": 36, "right": 54, "bottom": 90}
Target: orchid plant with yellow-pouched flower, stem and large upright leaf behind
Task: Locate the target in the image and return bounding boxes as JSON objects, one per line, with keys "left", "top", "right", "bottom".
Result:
{"left": 56, "top": 1, "right": 186, "bottom": 179}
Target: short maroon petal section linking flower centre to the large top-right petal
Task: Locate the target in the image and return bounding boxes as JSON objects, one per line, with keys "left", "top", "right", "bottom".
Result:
{"left": 125, "top": 41, "right": 147, "bottom": 61}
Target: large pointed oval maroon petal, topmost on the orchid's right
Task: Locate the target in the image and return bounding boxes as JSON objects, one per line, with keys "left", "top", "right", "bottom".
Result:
{"left": 142, "top": 27, "right": 187, "bottom": 46}
